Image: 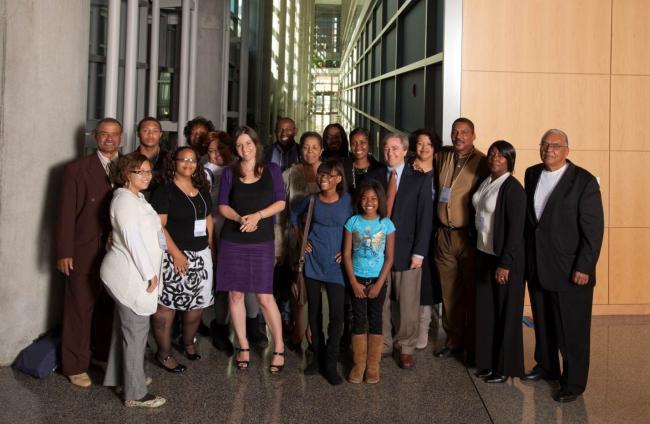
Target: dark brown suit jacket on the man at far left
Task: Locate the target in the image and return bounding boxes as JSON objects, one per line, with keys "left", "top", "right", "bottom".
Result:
{"left": 56, "top": 153, "right": 113, "bottom": 274}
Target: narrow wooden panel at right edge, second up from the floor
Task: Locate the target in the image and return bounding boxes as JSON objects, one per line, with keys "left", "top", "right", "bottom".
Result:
{"left": 609, "top": 151, "right": 650, "bottom": 227}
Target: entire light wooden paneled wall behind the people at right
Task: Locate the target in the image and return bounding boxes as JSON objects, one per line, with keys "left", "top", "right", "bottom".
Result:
{"left": 461, "top": 0, "right": 650, "bottom": 314}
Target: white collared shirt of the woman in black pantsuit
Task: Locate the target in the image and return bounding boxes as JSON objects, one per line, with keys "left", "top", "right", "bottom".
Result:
{"left": 472, "top": 172, "right": 510, "bottom": 255}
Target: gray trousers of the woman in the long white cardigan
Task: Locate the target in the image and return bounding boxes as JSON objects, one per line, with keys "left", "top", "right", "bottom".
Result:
{"left": 104, "top": 302, "right": 150, "bottom": 400}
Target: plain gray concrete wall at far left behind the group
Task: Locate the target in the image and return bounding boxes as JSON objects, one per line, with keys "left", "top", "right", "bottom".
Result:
{"left": 0, "top": 0, "right": 90, "bottom": 365}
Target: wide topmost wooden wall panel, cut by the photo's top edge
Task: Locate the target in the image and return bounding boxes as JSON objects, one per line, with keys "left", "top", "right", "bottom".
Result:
{"left": 462, "top": 0, "right": 611, "bottom": 75}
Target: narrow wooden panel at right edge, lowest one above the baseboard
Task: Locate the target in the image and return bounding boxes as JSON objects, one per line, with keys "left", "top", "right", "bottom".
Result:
{"left": 609, "top": 228, "right": 650, "bottom": 305}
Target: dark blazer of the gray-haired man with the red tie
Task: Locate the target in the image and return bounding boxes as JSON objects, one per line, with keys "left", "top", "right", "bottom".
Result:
{"left": 366, "top": 164, "right": 433, "bottom": 271}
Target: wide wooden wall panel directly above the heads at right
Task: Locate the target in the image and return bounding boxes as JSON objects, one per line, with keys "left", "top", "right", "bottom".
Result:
{"left": 461, "top": 71, "right": 610, "bottom": 150}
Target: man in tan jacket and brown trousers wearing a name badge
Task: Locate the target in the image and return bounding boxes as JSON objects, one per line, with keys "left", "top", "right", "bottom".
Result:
{"left": 434, "top": 118, "right": 488, "bottom": 365}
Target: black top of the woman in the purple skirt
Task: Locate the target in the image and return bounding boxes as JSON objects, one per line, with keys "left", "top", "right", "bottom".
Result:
{"left": 219, "top": 165, "right": 276, "bottom": 243}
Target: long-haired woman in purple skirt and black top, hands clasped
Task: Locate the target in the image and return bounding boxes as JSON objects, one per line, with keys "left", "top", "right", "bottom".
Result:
{"left": 217, "top": 126, "right": 285, "bottom": 374}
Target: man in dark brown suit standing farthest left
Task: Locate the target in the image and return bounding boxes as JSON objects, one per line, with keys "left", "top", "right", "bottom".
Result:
{"left": 56, "top": 118, "right": 122, "bottom": 387}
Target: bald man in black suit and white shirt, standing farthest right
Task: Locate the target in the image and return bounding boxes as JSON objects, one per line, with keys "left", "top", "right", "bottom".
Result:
{"left": 524, "top": 129, "right": 604, "bottom": 402}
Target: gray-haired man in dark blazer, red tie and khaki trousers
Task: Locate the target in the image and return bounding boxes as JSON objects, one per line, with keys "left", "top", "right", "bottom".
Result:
{"left": 368, "top": 134, "right": 433, "bottom": 368}
